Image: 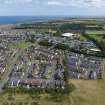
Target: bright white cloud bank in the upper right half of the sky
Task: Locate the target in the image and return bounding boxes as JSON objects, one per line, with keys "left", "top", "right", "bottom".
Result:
{"left": 48, "top": 0, "right": 105, "bottom": 8}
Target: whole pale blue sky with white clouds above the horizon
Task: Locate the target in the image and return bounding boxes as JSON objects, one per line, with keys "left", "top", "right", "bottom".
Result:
{"left": 0, "top": 0, "right": 105, "bottom": 16}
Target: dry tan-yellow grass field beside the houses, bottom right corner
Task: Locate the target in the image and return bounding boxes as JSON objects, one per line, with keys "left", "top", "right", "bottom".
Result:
{"left": 70, "top": 80, "right": 105, "bottom": 105}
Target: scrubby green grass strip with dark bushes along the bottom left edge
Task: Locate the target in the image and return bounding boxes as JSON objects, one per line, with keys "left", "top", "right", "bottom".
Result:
{"left": 0, "top": 93, "right": 72, "bottom": 105}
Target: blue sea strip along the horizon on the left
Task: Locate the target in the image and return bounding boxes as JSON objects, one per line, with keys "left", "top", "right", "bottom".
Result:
{"left": 0, "top": 16, "right": 63, "bottom": 24}
